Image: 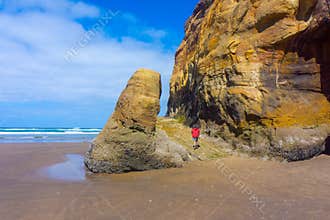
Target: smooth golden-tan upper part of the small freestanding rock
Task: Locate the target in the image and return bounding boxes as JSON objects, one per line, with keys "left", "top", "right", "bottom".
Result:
{"left": 102, "top": 69, "right": 161, "bottom": 135}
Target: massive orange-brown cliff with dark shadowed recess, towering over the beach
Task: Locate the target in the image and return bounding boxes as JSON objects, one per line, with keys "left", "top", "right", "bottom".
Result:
{"left": 168, "top": 0, "right": 330, "bottom": 160}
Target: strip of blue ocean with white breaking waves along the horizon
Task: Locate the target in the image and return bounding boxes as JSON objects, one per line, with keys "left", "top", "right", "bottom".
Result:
{"left": 0, "top": 128, "right": 101, "bottom": 143}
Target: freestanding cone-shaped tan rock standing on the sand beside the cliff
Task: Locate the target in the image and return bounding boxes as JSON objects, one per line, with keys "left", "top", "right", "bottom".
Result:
{"left": 85, "top": 69, "right": 190, "bottom": 173}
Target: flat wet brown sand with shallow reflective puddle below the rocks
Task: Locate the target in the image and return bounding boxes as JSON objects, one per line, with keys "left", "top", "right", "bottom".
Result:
{"left": 0, "top": 143, "right": 330, "bottom": 220}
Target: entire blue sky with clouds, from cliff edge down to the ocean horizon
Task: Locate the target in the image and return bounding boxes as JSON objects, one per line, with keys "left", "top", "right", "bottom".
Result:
{"left": 0, "top": 0, "right": 198, "bottom": 127}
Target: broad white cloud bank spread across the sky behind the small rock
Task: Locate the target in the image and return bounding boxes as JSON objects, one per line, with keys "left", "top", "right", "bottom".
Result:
{"left": 0, "top": 0, "right": 173, "bottom": 109}
